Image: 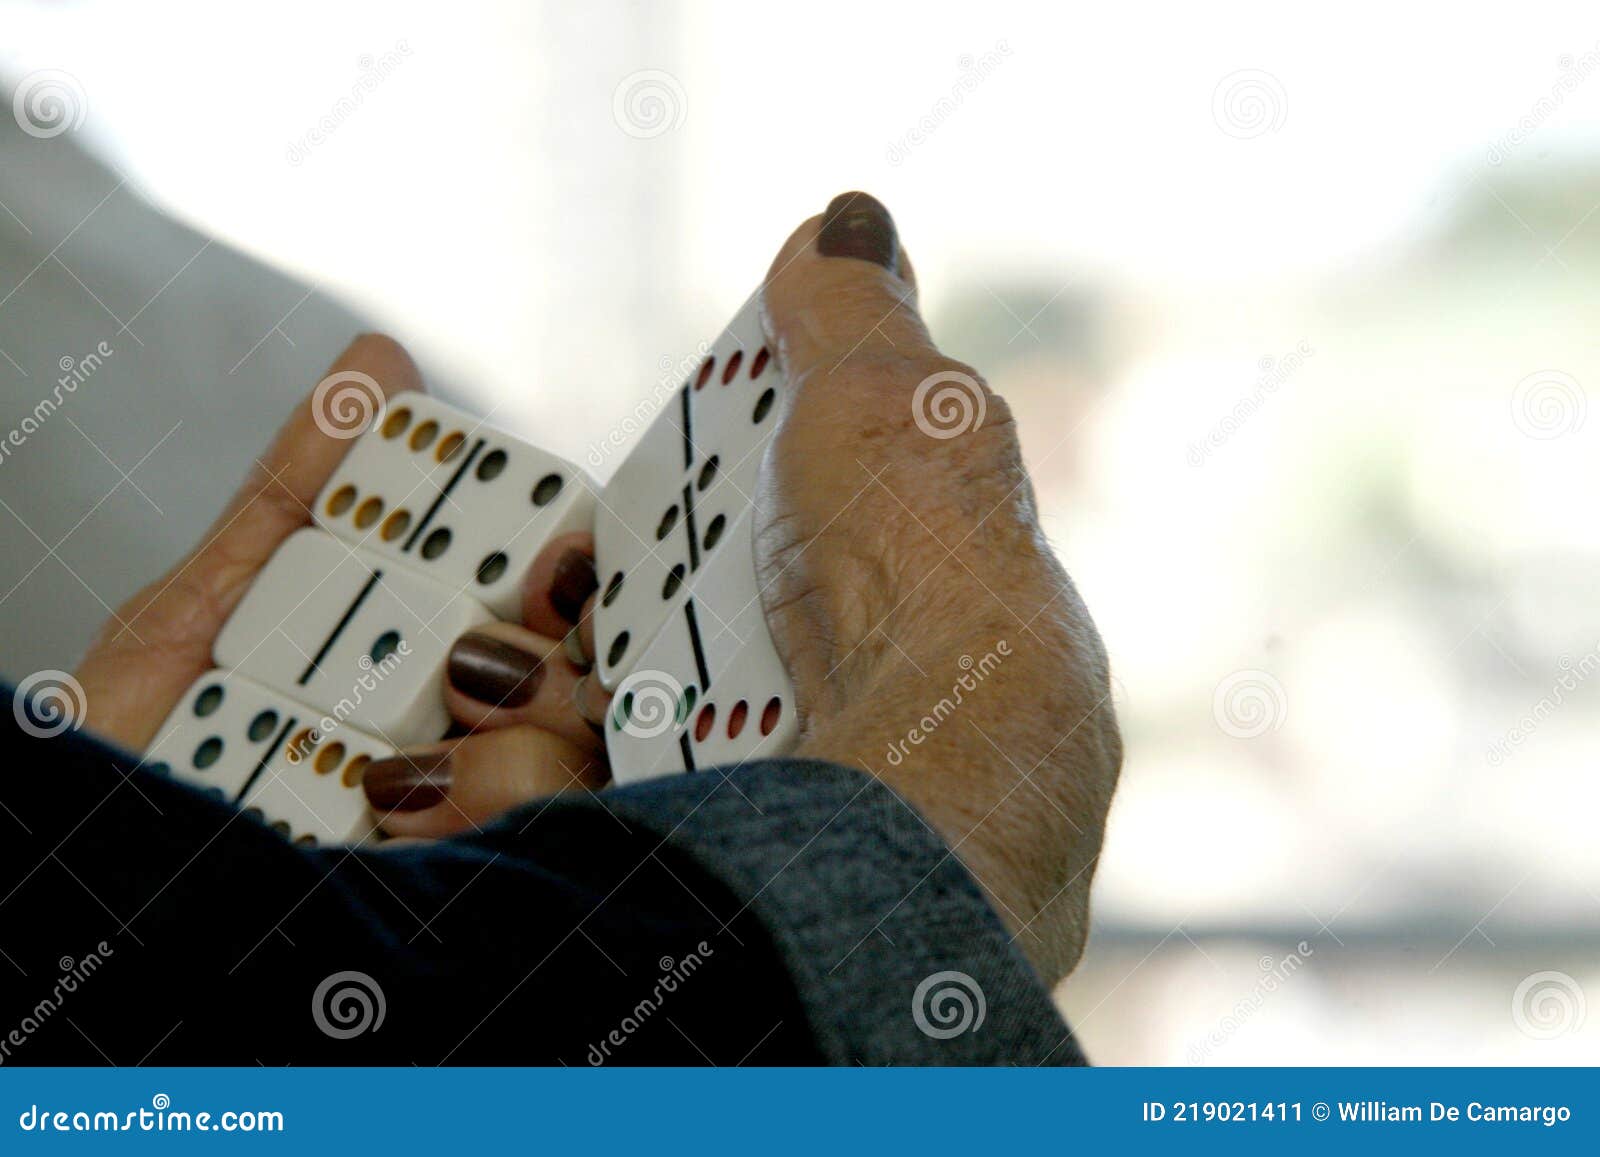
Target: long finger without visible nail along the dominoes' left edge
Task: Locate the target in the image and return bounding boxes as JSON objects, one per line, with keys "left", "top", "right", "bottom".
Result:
{"left": 77, "top": 334, "right": 422, "bottom": 749}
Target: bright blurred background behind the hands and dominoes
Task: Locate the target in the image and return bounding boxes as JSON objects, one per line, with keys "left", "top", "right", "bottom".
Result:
{"left": 0, "top": 0, "right": 1600, "bottom": 1064}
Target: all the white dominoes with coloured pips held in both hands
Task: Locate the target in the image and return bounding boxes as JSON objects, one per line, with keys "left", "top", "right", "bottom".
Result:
{"left": 146, "top": 304, "right": 795, "bottom": 843}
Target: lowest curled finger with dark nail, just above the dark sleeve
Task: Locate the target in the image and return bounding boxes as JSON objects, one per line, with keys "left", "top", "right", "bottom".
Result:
{"left": 362, "top": 727, "right": 611, "bottom": 835}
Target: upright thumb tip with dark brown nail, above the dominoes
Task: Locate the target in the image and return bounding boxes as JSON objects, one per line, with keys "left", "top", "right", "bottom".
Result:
{"left": 763, "top": 192, "right": 936, "bottom": 379}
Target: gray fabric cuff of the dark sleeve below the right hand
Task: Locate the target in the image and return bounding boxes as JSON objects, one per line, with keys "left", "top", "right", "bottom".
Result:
{"left": 578, "top": 760, "right": 1085, "bottom": 1064}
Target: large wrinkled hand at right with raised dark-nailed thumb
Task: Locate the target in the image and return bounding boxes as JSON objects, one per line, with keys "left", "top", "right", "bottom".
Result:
{"left": 757, "top": 194, "right": 1122, "bottom": 983}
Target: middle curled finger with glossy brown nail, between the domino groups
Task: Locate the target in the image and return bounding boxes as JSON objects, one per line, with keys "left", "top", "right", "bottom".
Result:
{"left": 445, "top": 623, "right": 602, "bottom": 751}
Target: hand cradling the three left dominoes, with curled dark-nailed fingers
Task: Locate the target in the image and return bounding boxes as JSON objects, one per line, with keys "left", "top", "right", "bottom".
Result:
{"left": 77, "top": 334, "right": 608, "bottom": 835}
